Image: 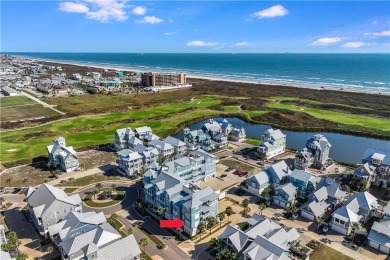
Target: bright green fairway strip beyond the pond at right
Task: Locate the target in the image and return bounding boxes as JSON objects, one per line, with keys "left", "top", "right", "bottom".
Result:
{"left": 268, "top": 103, "right": 390, "bottom": 131}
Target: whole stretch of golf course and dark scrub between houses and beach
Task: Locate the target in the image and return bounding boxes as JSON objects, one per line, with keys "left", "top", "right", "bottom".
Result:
{"left": 0, "top": 72, "right": 390, "bottom": 166}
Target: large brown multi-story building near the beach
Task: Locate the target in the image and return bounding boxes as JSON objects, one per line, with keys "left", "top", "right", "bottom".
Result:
{"left": 141, "top": 72, "right": 186, "bottom": 87}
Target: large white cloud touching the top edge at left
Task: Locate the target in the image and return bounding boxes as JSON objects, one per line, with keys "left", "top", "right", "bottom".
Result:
{"left": 58, "top": 0, "right": 128, "bottom": 22}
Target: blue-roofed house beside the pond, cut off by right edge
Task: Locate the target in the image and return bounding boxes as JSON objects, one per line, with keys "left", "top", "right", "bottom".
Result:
{"left": 362, "top": 148, "right": 390, "bottom": 188}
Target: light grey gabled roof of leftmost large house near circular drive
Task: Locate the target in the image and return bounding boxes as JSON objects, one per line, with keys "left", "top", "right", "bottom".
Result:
{"left": 27, "top": 183, "right": 81, "bottom": 218}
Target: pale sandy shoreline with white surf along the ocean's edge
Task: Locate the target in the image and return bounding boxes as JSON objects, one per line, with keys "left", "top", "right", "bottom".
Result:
{"left": 12, "top": 55, "right": 390, "bottom": 96}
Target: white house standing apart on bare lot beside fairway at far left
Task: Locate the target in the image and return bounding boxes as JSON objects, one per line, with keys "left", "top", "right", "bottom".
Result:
{"left": 47, "top": 137, "right": 79, "bottom": 172}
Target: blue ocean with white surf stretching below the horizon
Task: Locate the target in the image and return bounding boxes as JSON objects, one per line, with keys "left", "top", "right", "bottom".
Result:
{"left": 9, "top": 53, "right": 390, "bottom": 94}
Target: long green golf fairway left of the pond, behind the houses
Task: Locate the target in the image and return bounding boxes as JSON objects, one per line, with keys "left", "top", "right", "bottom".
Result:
{"left": 0, "top": 98, "right": 220, "bottom": 162}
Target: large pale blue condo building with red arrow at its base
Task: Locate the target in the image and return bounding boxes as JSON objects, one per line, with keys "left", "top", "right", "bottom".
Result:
{"left": 144, "top": 171, "right": 218, "bottom": 236}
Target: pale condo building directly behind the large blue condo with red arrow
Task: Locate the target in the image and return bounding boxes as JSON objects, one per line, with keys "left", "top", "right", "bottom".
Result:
{"left": 161, "top": 149, "right": 216, "bottom": 182}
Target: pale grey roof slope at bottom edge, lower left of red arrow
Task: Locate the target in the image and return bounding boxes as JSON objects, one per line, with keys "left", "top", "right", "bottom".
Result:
{"left": 97, "top": 235, "right": 141, "bottom": 260}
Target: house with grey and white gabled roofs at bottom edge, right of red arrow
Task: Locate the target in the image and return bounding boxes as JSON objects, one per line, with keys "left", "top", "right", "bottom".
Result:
{"left": 218, "top": 214, "right": 300, "bottom": 260}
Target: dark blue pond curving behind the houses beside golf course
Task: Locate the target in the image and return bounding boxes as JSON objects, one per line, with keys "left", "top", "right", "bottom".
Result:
{"left": 176, "top": 117, "right": 390, "bottom": 163}
